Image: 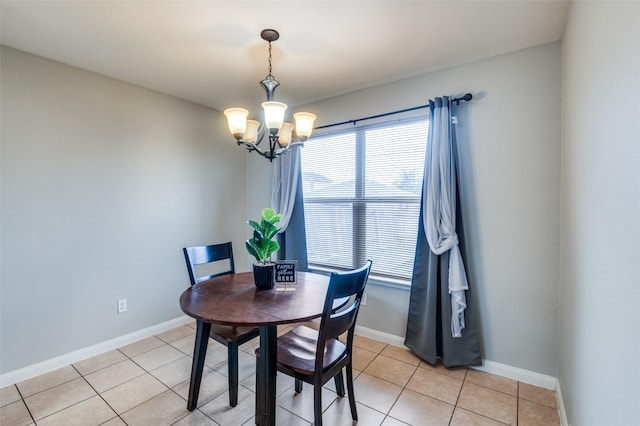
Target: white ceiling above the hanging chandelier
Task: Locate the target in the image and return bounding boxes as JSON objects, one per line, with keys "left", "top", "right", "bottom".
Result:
{"left": 0, "top": 0, "right": 569, "bottom": 110}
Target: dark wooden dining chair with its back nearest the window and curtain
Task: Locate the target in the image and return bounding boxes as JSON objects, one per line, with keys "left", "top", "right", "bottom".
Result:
{"left": 277, "top": 260, "right": 371, "bottom": 426}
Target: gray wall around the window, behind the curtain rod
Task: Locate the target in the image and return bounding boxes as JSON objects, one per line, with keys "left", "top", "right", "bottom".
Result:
{"left": 248, "top": 43, "right": 560, "bottom": 376}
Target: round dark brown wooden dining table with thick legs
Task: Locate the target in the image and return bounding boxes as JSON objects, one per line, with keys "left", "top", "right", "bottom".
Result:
{"left": 180, "top": 272, "right": 329, "bottom": 426}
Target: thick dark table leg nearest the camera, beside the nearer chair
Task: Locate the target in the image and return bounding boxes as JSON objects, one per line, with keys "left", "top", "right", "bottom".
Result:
{"left": 256, "top": 326, "right": 278, "bottom": 426}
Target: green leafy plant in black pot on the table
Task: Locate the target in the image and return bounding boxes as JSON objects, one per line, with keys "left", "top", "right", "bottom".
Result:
{"left": 246, "top": 207, "right": 282, "bottom": 290}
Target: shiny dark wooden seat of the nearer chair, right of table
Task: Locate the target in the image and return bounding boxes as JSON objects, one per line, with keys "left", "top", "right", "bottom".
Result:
{"left": 277, "top": 326, "right": 347, "bottom": 375}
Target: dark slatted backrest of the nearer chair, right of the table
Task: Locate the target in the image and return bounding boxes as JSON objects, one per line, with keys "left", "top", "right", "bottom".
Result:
{"left": 316, "top": 260, "right": 371, "bottom": 369}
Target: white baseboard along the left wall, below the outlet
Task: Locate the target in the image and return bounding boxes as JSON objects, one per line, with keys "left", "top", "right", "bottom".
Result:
{"left": 0, "top": 316, "right": 193, "bottom": 388}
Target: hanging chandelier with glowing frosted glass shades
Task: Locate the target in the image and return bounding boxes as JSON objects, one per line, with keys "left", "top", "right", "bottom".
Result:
{"left": 224, "top": 29, "right": 316, "bottom": 161}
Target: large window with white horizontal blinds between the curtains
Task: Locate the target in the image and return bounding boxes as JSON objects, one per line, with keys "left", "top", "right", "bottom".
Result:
{"left": 302, "top": 118, "right": 428, "bottom": 280}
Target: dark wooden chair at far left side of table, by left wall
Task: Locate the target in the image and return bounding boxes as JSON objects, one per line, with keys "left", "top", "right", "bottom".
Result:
{"left": 183, "top": 242, "right": 259, "bottom": 407}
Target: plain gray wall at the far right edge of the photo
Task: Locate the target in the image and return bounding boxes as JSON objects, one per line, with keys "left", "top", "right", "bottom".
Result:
{"left": 558, "top": 2, "right": 640, "bottom": 426}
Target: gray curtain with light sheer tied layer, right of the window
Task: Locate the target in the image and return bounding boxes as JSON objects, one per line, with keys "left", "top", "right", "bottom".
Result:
{"left": 405, "top": 96, "right": 482, "bottom": 367}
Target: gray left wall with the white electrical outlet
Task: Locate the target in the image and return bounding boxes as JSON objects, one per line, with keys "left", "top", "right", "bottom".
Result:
{"left": 0, "top": 47, "right": 247, "bottom": 373}
